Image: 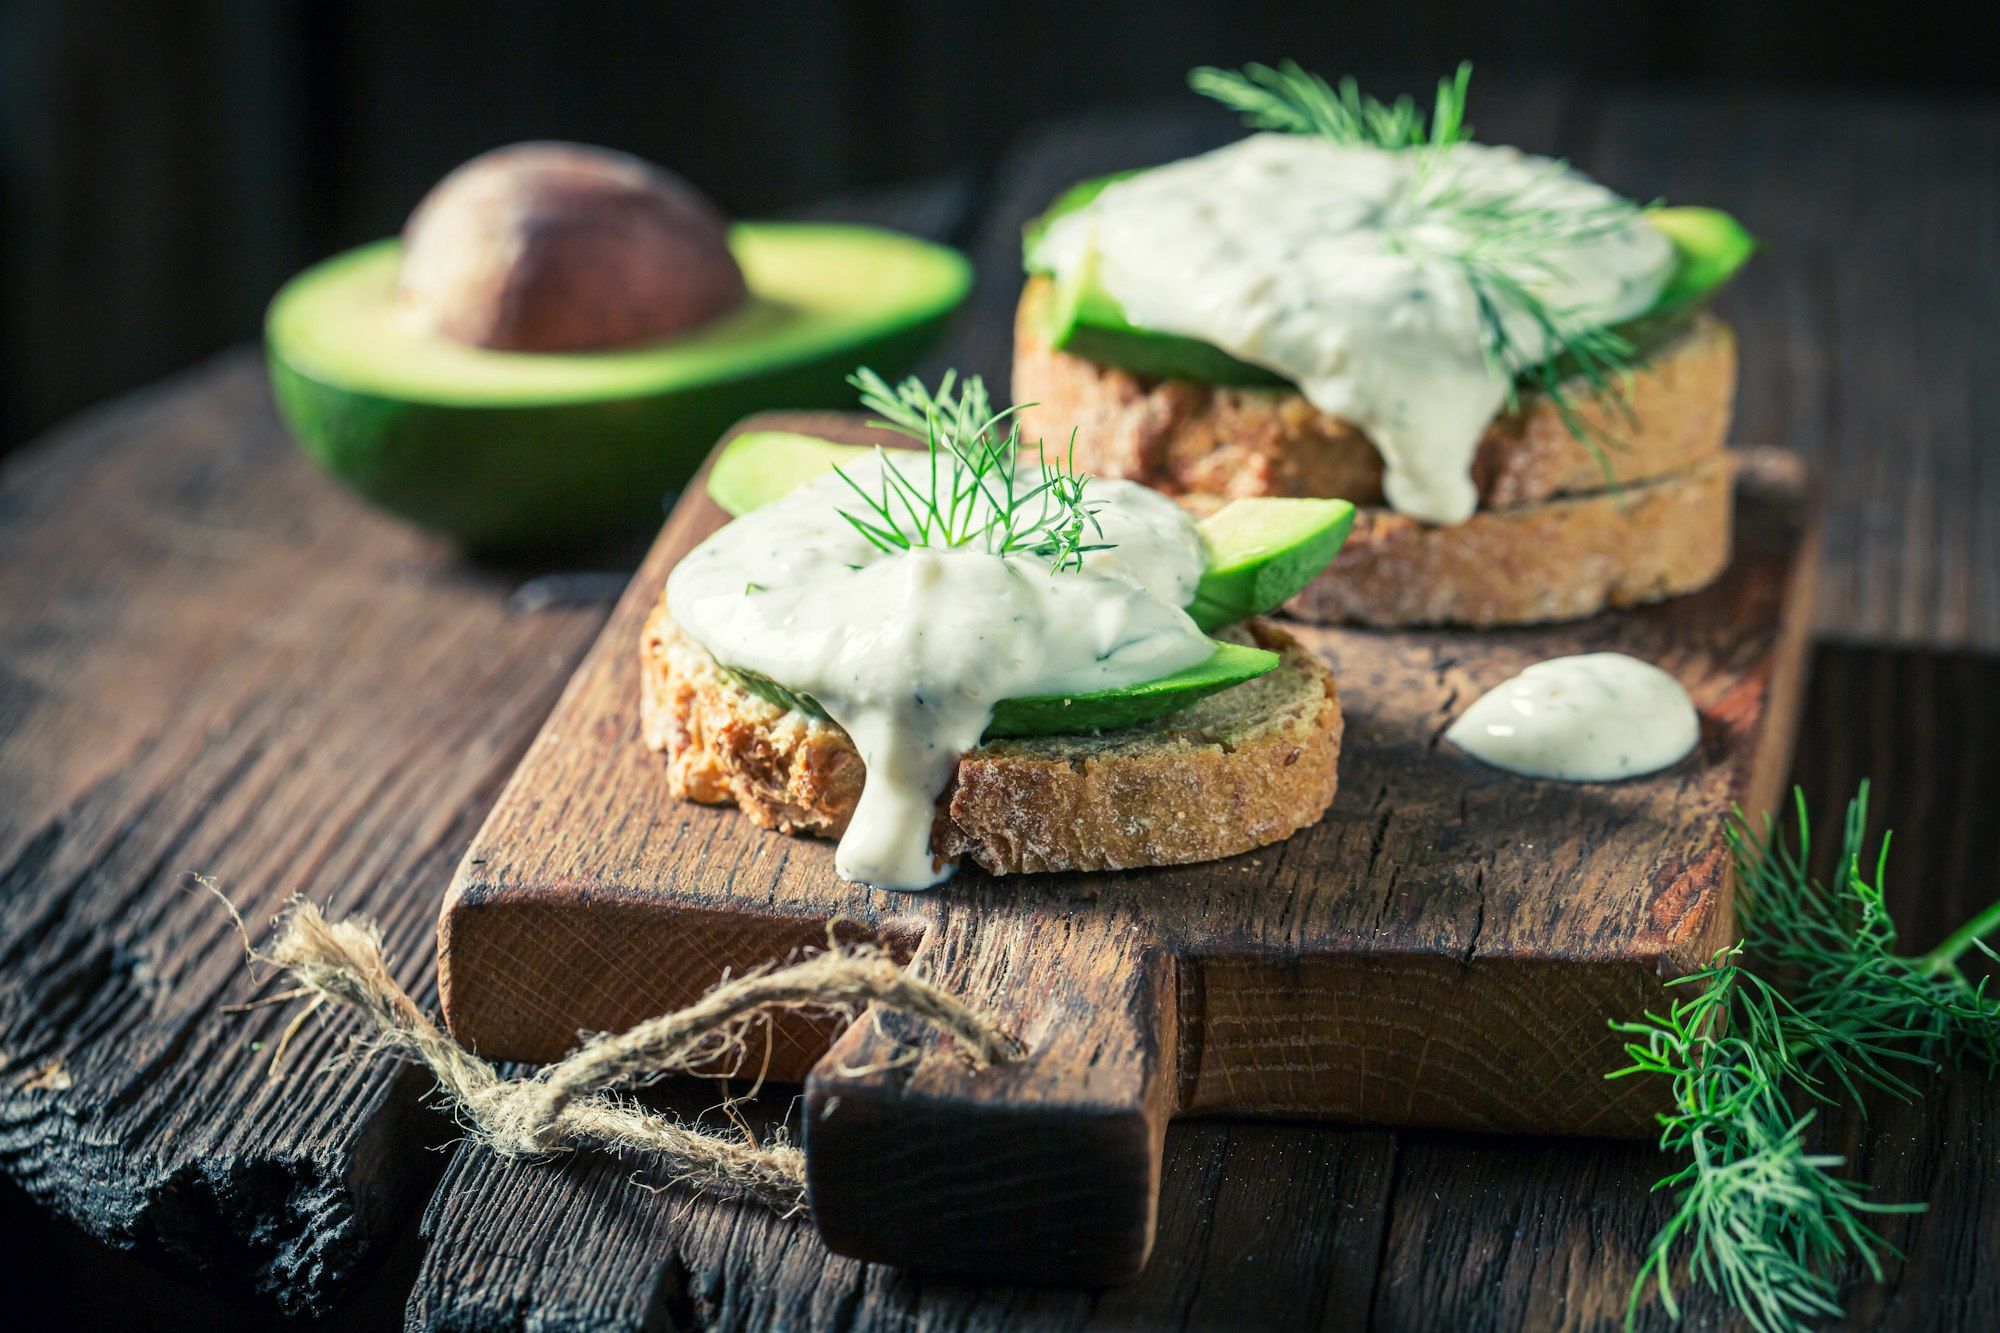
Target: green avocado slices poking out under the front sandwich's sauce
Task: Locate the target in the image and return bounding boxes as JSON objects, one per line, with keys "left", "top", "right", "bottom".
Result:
{"left": 708, "top": 430, "right": 1354, "bottom": 737}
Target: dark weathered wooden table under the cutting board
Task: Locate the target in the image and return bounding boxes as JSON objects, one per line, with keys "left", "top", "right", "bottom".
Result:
{"left": 11, "top": 88, "right": 2000, "bottom": 1329}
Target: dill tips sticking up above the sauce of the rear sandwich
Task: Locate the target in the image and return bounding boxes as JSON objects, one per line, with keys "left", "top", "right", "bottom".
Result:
{"left": 1188, "top": 60, "right": 1472, "bottom": 148}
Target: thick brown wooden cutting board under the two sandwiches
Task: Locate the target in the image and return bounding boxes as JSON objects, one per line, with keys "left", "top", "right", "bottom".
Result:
{"left": 440, "top": 414, "right": 1810, "bottom": 1152}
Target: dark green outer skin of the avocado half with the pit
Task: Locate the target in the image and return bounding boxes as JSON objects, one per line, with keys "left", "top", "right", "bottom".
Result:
{"left": 266, "top": 332, "right": 950, "bottom": 556}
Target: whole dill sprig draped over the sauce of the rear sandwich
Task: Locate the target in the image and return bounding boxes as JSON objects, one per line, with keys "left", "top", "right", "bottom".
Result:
{"left": 1188, "top": 60, "right": 1640, "bottom": 482}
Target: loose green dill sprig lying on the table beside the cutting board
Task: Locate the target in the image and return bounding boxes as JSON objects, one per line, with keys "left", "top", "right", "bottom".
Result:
{"left": 1608, "top": 783, "right": 2000, "bottom": 1333}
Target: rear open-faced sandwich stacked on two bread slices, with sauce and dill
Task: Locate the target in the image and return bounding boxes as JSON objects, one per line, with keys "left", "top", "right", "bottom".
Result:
{"left": 1014, "top": 64, "right": 1754, "bottom": 624}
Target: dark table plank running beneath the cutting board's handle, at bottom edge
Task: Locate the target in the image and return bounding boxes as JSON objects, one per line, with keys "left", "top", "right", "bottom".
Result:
{"left": 408, "top": 1097, "right": 1394, "bottom": 1331}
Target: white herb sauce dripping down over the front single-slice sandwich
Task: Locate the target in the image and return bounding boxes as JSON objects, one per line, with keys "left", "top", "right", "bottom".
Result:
{"left": 666, "top": 452, "right": 1214, "bottom": 889}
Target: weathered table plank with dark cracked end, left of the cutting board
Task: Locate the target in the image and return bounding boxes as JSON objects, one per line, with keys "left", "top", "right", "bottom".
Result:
{"left": 0, "top": 354, "right": 602, "bottom": 1311}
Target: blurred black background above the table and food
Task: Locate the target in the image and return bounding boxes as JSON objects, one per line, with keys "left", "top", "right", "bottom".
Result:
{"left": 0, "top": 0, "right": 2000, "bottom": 450}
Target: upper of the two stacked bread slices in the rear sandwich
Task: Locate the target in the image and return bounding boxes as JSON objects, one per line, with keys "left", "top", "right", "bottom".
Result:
{"left": 1014, "top": 278, "right": 1736, "bottom": 508}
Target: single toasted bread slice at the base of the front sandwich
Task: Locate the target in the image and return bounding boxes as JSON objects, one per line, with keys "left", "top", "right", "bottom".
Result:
{"left": 640, "top": 600, "right": 1340, "bottom": 875}
